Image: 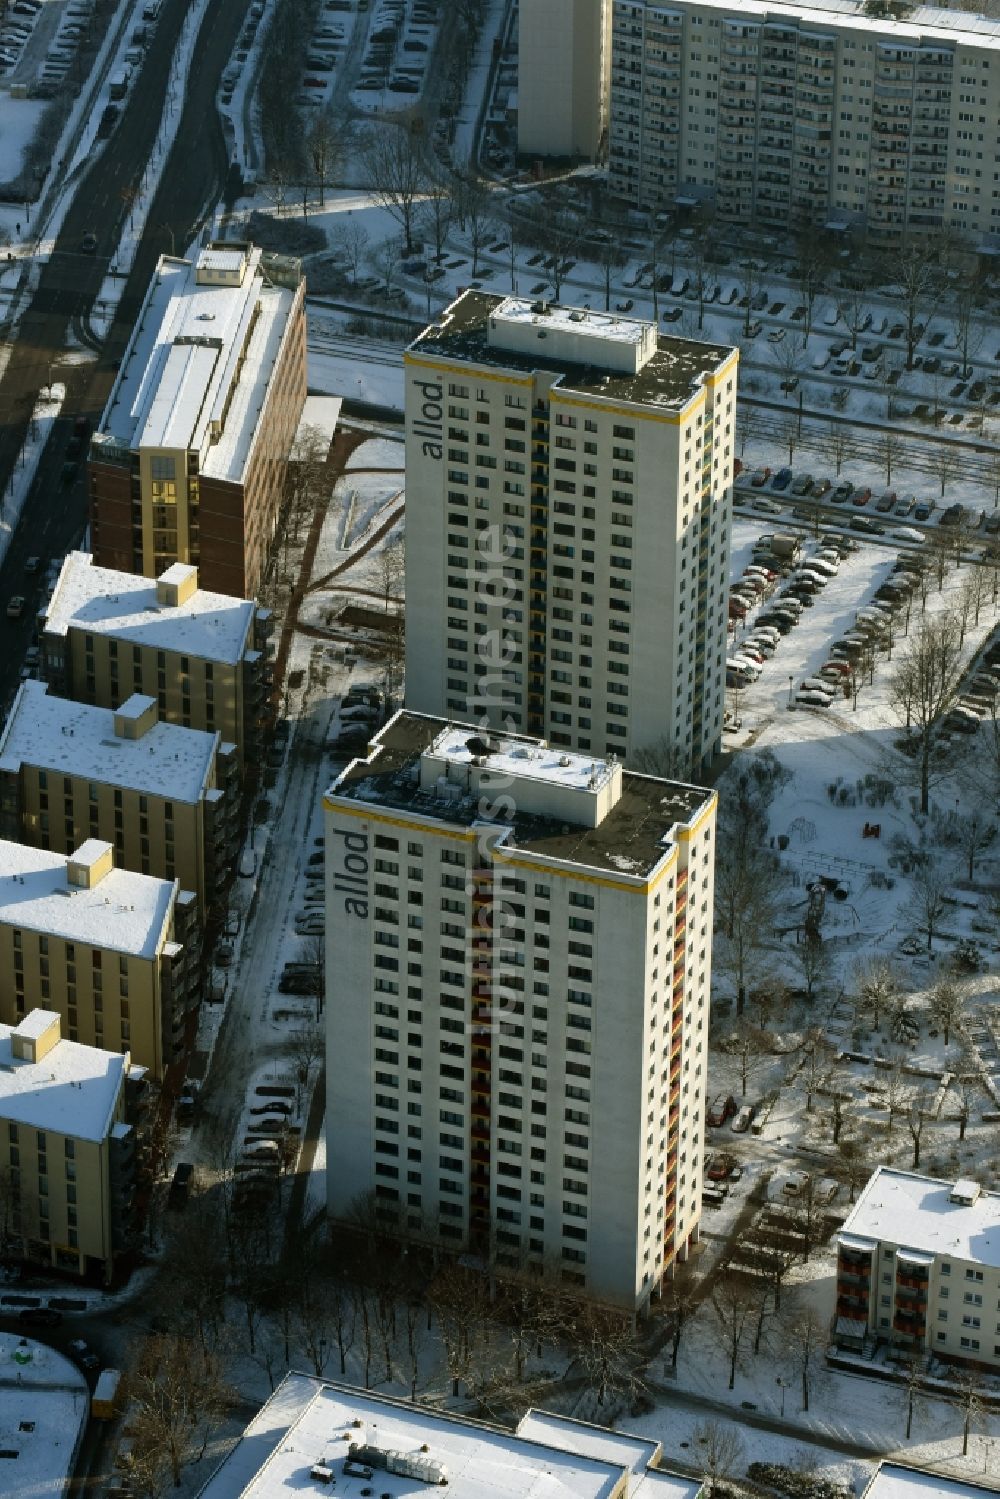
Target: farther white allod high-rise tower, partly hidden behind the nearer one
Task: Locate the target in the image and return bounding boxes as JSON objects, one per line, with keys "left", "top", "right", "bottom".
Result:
{"left": 405, "top": 292, "right": 738, "bottom": 776}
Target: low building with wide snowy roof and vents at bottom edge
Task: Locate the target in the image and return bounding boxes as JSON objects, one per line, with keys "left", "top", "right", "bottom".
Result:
{"left": 198, "top": 1373, "right": 705, "bottom": 1499}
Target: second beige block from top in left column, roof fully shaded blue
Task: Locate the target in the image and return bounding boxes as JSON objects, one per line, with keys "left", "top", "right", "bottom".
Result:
{"left": 0, "top": 682, "right": 240, "bottom": 919}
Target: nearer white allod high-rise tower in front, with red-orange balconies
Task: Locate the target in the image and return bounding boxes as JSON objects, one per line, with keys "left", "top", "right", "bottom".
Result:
{"left": 325, "top": 711, "right": 715, "bottom": 1309}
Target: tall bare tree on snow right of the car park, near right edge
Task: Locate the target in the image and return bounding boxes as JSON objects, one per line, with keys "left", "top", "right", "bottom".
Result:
{"left": 889, "top": 613, "right": 963, "bottom": 814}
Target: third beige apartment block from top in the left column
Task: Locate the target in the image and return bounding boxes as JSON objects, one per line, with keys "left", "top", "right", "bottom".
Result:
{"left": 0, "top": 839, "right": 199, "bottom": 1081}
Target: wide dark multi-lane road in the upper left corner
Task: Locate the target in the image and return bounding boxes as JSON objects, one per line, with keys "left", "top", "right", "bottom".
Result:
{"left": 0, "top": 0, "right": 249, "bottom": 716}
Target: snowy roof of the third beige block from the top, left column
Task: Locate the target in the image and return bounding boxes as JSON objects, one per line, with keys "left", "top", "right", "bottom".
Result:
{"left": 0, "top": 839, "right": 174, "bottom": 958}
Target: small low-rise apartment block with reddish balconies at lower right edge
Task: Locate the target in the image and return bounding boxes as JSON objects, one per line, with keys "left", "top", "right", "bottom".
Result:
{"left": 835, "top": 1166, "right": 1000, "bottom": 1369}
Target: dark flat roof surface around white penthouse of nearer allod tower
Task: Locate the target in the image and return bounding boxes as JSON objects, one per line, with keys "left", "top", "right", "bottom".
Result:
{"left": 327, "top": 711, "right": 715, "bottom": 883}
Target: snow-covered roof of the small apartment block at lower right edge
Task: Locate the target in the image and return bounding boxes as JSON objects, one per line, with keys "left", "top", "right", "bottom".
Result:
{"left": 840, "top": 1166, "right": 1000, "bottom": 1268}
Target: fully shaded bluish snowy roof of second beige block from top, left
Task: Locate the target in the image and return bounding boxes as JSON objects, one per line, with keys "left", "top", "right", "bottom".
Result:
{"left": 0, "top": 682, "right": 219, "bottom": 802}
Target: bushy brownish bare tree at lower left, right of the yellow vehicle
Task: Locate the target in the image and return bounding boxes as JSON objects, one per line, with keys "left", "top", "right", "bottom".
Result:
{"left": 126, "top": 1334, "right": 232, "bottom": 1487}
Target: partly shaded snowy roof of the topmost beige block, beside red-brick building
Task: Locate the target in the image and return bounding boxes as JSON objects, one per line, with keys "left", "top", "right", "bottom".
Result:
{"left": 45, "top": 552, "right": 255, "bottom": 666}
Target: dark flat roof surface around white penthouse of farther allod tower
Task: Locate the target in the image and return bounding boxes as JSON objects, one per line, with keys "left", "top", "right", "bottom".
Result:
{"left": 406, "top": 291, "right": 735, "bottom": 411}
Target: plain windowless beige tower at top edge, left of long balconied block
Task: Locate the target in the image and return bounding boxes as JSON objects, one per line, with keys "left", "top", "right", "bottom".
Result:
{"left": 517, "top": 0, "right": 612, "bottom": 160}
